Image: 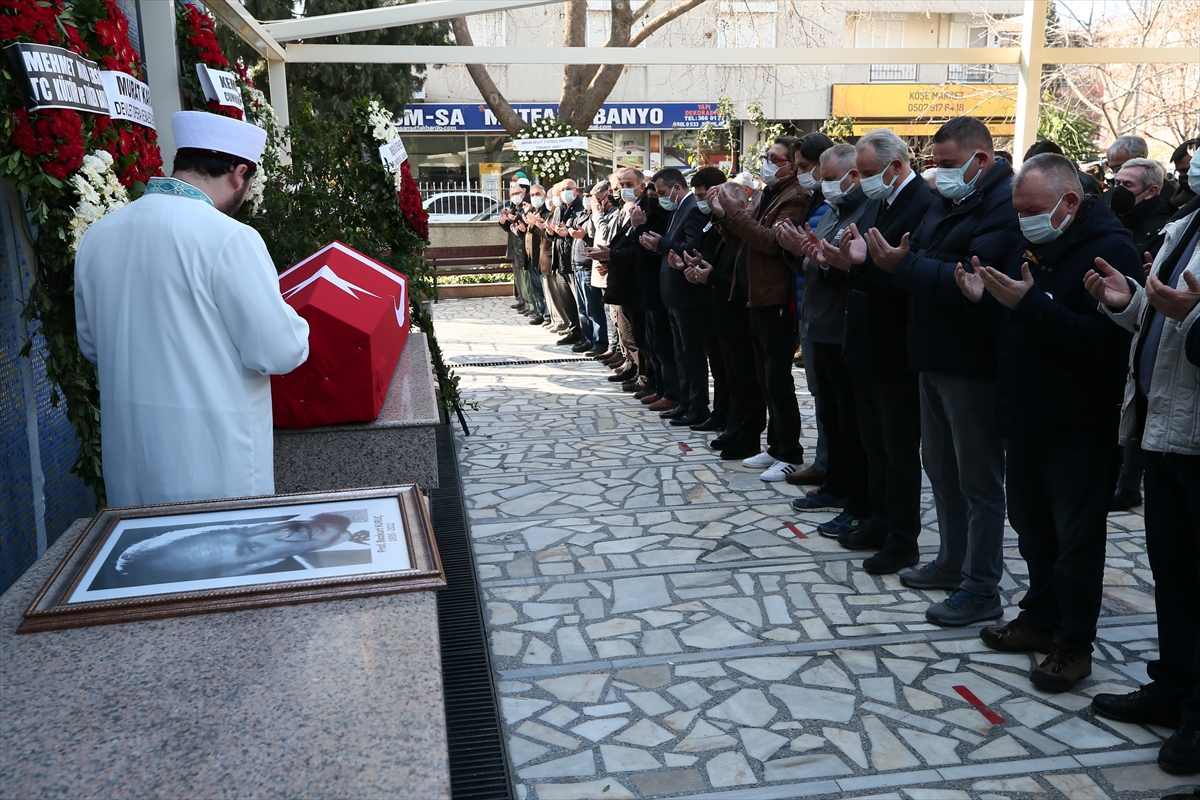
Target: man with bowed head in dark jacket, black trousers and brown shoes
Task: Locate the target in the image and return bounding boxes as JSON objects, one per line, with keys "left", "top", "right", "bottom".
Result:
{"left": 955, "top": 154, "right": 1142, "bottom": 692}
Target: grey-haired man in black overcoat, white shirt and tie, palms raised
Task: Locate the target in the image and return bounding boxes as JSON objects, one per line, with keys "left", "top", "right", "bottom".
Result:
{"left": 806, "top": 128, "right": 936, "bottom": 573}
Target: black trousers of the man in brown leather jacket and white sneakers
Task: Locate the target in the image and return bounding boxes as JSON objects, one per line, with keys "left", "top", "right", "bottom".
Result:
{"left": 750, "top": 306, "right": 804, "bottom": 464}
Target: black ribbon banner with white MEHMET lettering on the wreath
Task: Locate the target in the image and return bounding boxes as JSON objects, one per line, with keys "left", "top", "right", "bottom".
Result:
{"left": 4, "top": 42, "right": 108, "bottom": 116}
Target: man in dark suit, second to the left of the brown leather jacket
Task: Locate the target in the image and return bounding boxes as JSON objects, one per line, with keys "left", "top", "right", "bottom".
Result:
{"left": 641, "top": 167, "right": 708, "bottom": 426}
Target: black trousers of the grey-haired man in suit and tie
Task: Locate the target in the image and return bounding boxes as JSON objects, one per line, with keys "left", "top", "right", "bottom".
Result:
{"left": 854, "top": 372, "right": 920, "bottom": 549}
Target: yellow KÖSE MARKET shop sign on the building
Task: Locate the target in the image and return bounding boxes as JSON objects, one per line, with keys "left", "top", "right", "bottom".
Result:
{"left": 832, "top": 84, "right": 1016, "bottom": 120}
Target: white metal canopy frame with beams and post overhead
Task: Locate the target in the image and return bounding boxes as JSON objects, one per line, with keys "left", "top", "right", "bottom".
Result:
{"left": 206, "top": 0, "right": 1198, "bottom": 158}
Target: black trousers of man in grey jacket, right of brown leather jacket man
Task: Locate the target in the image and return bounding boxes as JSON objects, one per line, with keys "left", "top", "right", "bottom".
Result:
{"left": 804, "top": 342, "right": 871, "bottom": 518}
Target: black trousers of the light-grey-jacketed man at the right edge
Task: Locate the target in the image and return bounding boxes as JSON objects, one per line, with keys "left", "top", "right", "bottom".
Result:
{"left": 1145, "top": 451, "right": 1200, "bottom": 727}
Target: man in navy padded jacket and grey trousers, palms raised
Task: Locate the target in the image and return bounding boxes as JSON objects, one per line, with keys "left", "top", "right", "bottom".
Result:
{"left": 865, "top": 116, "right": 1020, "bottom": 625}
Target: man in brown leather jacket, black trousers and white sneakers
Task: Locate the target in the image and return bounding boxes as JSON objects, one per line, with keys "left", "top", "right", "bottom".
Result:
{"left": 709, "top": 137, "right": 809, "bottom": 481}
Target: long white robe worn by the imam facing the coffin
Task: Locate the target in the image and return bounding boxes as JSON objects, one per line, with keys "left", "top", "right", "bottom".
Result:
{"left": 74, "top": 194, "right": 308, "bottom": 506}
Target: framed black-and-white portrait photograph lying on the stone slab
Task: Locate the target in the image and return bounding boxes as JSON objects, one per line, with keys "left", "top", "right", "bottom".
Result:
{"left": 18, "top": 486, "right": 445, "bottom": 633}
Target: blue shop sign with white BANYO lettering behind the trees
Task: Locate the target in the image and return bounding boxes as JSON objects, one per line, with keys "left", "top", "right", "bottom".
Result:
{"left": 396, "top": 103, "right": 725, "bottom": 133}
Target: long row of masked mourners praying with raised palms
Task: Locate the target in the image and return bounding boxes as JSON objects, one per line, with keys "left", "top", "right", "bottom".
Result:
{"left": 500, "top": 118, "right": 1200, "bottom": 774}
